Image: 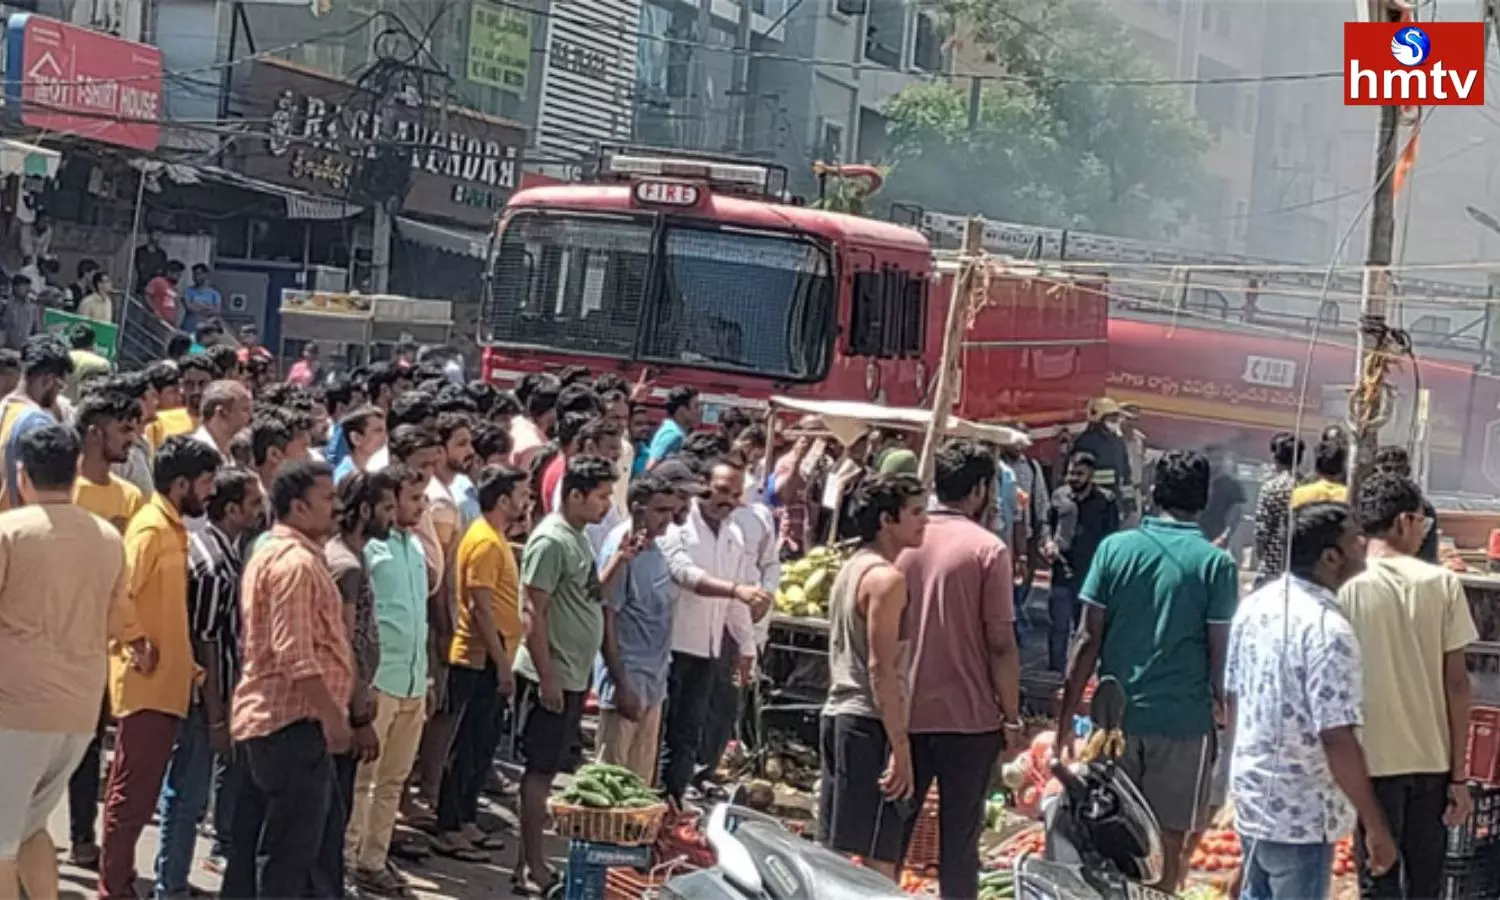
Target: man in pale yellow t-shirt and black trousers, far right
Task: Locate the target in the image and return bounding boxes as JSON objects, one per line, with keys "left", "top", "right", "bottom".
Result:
{"left": 1338, "top": 473, "right": 1479, "bottom": 897}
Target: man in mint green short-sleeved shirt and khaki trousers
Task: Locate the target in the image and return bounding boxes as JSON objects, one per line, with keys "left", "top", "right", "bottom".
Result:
{"left": 345, "top": 462, "right": 429, "bottom": 897}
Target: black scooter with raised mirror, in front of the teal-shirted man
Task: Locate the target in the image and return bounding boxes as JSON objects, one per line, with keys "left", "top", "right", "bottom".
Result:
{"left": 1016, "top": 677, "right": 1172, "bottom": 900}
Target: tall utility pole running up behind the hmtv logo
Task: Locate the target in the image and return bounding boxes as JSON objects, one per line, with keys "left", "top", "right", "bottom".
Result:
{"left": 1349, "top": 0, "right": 1401, "bottom": 503}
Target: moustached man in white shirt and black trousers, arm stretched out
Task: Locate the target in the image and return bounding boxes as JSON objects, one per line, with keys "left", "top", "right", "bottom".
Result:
{"left": 660, "top": 462, "right": 780, "bottom": 803}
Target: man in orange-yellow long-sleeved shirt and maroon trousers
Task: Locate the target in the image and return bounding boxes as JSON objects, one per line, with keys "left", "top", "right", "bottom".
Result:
{"left": 99, "top": 435, "right": 221, "bottom": 900}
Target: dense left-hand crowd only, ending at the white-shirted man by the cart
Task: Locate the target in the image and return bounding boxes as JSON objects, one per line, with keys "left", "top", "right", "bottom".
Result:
{"left": 0, "top": 339, "right": 810, "bottom": 899}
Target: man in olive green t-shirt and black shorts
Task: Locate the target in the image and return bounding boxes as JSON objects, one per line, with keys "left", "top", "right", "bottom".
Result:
{"left": 515, "top": 456, "right": 615, "bottom": 896}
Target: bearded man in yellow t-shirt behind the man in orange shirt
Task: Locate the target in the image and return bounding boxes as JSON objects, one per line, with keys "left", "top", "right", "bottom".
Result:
{"left": 74, "top": 392, "right": 144, "bottom": 534}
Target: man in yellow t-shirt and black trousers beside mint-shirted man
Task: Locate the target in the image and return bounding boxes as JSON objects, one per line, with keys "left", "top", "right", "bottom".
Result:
{"left": 434, "top": 467, "right": 531, "bottom": 854}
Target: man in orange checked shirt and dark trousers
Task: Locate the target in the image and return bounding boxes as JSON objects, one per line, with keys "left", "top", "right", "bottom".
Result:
{"left": 222, "top": 461, "right": 352, "bottom": 897}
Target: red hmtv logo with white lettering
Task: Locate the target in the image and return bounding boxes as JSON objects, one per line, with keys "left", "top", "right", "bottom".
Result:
{"left": 1344, "top": 23, "right": 1485, "bottom": 107}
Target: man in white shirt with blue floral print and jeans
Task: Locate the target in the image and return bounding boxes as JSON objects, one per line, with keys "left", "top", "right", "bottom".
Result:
{"left": 1226, "top": 503, "right": 1397, "bottom": 900}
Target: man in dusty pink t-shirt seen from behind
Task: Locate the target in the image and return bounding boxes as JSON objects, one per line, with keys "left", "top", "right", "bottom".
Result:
{"left": 897, "top": 440, "right": 1022, "bottom": 897}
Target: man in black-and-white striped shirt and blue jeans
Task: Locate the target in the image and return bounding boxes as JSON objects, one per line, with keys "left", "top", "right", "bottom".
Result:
{"left": 156, "top": 468, "right": 266, "bottom": 897}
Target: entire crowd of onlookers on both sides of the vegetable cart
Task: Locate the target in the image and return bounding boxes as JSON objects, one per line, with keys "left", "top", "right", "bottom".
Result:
{"left": 0, "top": 320, "right": 1475, "bottom": 900}
